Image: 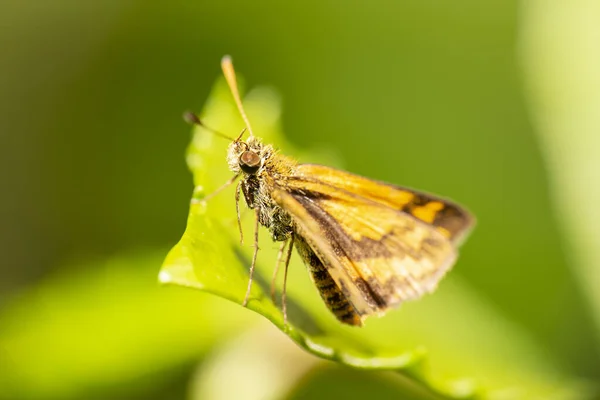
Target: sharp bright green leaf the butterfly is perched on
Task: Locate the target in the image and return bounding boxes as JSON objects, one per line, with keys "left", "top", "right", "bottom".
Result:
{"left": 160, "top": 76, "right": 586, "bottom": 399}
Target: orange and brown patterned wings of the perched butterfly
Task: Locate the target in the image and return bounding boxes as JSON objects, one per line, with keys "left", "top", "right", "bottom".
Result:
{"left": 272, "top": 165, "right": 471, "bottom": 322}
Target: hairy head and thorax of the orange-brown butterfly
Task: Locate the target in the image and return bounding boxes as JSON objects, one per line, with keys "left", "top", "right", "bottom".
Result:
{"left": 227, "top": 137, "right": 297, "bottom": 241}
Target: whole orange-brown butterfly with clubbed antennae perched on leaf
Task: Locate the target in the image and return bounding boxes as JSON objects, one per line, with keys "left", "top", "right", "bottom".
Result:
{"left": 185, "top": 56, "right": 475, "bottom": 326}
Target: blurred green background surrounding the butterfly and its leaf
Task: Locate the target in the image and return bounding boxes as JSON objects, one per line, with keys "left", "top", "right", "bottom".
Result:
{"left": 0, "top": 0, "right": 600, "bottom": 399}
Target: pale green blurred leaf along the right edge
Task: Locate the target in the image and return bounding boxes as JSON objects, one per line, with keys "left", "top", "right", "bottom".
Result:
{"left": 521, "top": 1, "right": 600, "bottom": 342}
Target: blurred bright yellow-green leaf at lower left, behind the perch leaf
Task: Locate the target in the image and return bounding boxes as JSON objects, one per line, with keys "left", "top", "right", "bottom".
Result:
{"left": 0, "top": 250, "right": 253, "bottom": 400}
